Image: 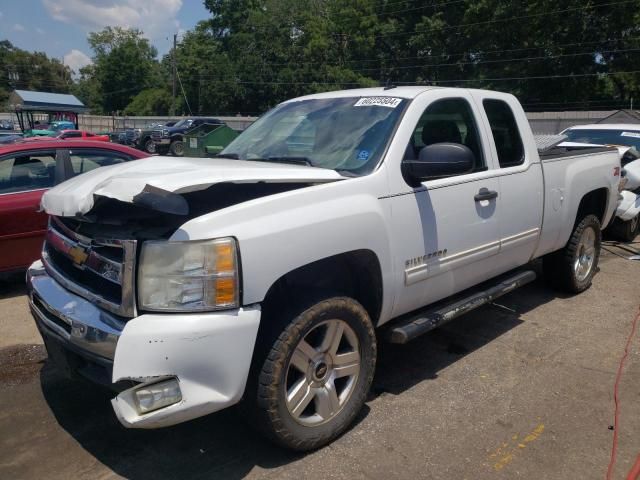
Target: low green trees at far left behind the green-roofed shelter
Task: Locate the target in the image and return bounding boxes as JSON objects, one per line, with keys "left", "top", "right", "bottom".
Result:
{"left": 0, "top": 40, "right": 72, "bottom": 110}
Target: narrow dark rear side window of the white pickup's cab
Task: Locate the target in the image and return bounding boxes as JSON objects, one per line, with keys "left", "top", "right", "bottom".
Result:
{"left": 482, "top": 100, "right": 524, "bottom": 168}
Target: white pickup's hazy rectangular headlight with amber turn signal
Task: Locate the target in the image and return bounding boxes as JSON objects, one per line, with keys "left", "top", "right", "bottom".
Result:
{"left": 138, "top": 238, "right": 239, "bottom": 312}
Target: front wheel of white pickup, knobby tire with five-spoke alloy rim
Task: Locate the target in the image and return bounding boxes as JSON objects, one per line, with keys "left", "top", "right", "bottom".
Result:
{"left": 246, "top": 297, "right": 376, "bottom": 451}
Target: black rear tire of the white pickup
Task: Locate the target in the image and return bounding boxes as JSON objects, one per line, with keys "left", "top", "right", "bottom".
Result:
{"left": 543, "top": 215, "right": 602, "bottom": 293}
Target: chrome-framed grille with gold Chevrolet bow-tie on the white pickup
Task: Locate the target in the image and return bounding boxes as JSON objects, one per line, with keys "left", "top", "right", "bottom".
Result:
{"left": 42, "top": 217, "right": 136, "bottom": 317}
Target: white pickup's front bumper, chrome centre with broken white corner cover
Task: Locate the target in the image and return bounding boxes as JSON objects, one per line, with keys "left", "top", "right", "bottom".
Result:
{"left": 27, "top": 262, "right": 260, "bottom": 428}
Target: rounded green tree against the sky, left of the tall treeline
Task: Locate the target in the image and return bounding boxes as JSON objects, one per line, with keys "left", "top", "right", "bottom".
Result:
{"left": 87, "top": 27, "right": 162, "bottom": 113}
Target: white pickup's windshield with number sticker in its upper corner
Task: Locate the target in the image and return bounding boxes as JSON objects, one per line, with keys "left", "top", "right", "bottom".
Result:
{"left": 220, "top": 97, "right": 407, "bottom": 175}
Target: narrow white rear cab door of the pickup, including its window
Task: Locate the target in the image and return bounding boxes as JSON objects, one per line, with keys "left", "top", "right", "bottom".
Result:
{"left": 473, "top": 91, "right": 544, "bottom": 270}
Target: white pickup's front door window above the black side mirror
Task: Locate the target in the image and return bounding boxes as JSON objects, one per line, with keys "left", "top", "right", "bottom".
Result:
{"left": 405, "top": 98, "right": 487, "bottom": 172}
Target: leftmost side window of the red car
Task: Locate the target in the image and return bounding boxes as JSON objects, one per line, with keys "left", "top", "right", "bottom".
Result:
{"left": 0, "top": 152, "right": 56, "bottom": 194}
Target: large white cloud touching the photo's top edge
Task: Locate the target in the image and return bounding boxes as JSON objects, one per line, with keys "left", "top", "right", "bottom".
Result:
{"left": 42, "top": 0, "right": 183, "bottom": 43}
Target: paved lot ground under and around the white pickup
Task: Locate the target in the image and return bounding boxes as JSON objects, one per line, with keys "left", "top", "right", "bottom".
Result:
{"left": 0, "top": 244, "right": 640, "bottom": 480}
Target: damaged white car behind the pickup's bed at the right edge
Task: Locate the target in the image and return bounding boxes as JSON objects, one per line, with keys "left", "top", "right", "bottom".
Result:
{"left": 562, "top": 123, "right": 640, "bottom": 242}
